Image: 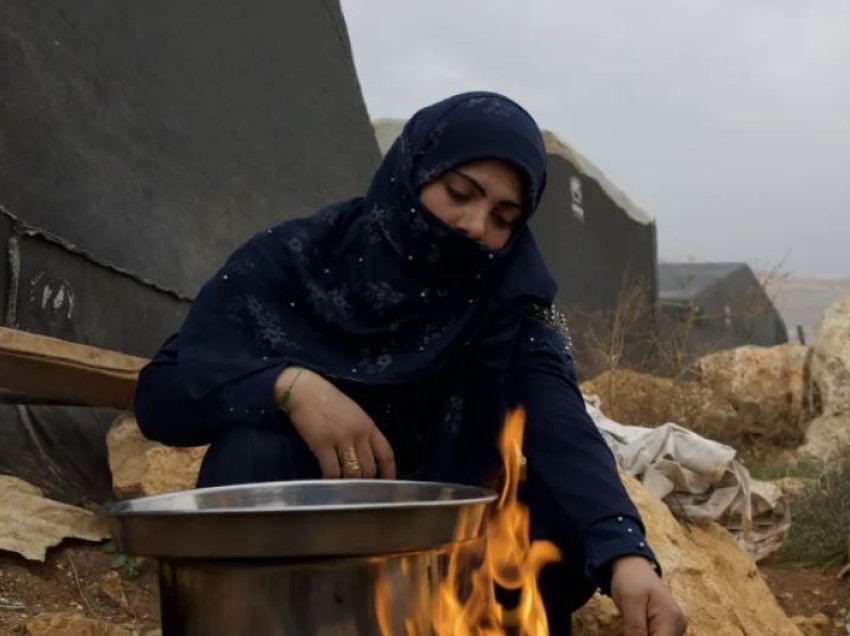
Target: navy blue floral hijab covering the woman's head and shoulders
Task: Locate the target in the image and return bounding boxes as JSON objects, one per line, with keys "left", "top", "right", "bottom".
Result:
{"left": 177, "top": 92, "right": 556, "bottom": 397}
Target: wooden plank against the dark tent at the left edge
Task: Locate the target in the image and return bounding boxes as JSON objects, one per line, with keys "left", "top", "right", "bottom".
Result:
{"left": 0, "top": 327, "right": 148, "bottom": 409}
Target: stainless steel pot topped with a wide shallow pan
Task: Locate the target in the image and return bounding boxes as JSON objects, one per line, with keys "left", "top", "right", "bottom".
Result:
{"left": 101, "top": 480, "right": 496, "bottom": 636}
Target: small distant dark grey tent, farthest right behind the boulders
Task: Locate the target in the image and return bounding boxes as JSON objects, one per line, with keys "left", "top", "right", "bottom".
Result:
{"left": 658, "top": 263, "right": 788, "bottom": 358}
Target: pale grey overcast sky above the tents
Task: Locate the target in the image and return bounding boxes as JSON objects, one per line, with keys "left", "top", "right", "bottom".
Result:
{"left": 342, "top": 0, "right": 850, "bottom": 277}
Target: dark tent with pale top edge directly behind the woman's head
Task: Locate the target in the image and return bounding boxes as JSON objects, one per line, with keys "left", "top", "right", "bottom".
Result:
{"left": 373, "top": 118, "right": 657, "bottom": 375}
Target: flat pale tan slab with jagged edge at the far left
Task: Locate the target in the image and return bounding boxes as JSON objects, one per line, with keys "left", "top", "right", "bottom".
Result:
{"left": 0, "top": 475, "right": 109, "bottom": 561}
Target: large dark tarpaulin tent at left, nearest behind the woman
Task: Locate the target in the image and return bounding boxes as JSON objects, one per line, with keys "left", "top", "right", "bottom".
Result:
{"left": 0, "top": 0, "right": 379, "bottom": 500}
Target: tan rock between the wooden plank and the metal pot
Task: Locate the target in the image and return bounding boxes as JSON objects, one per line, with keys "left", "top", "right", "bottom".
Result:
{"left": 106, "top": 415, "right": 207, "bottom": 498}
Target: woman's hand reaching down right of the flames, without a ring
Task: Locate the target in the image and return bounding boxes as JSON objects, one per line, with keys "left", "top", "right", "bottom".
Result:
{"left": 611, "top": 555, "right": 687, "bottom": 636}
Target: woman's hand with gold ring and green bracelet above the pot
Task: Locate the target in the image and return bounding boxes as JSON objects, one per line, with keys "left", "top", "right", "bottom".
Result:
{"left": 275, "top": 367, "right": 395, "bottom": 479}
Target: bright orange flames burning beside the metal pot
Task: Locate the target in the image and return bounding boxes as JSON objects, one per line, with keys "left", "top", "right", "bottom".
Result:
{"left": 375, "top": 410, "right": 560, "bottom": 636}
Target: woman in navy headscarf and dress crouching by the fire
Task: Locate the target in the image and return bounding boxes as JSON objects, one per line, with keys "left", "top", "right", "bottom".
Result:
{"left": 136, "top": 93, "right": 683, "bottom": 634}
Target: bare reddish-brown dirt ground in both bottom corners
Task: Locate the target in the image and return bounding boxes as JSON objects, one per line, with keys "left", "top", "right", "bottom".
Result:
{"left": 0, "top": 542, "right": 850, "bottom": 636}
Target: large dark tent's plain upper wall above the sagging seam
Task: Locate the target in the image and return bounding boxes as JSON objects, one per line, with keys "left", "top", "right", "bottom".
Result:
{"left": 0, "top": 0, "right": 379, "bottom": 306}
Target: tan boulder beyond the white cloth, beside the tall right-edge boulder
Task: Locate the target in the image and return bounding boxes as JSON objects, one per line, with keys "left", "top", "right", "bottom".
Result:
{"left": 694, "top": 344, "right": 811, "bottom": 446}
